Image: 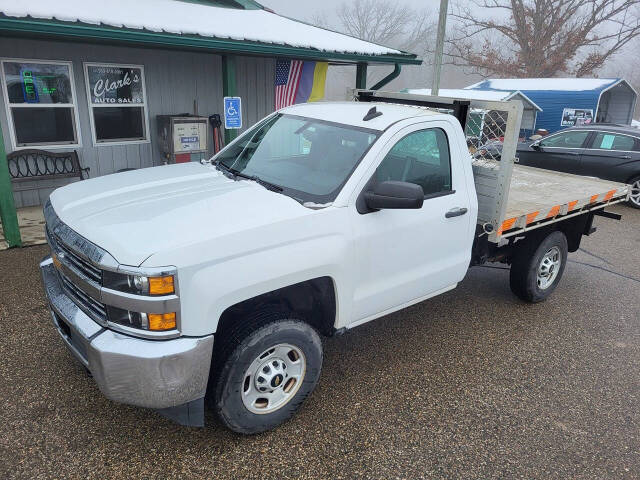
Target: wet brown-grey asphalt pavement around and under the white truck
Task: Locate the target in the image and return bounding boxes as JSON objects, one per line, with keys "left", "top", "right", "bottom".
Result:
{"left": 0, "top": 206, "right": 640, "bottom": 479}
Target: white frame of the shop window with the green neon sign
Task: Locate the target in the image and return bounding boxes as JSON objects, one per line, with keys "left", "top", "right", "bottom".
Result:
{"left": 0, "top": 57, "right": 82, "bottom": 151}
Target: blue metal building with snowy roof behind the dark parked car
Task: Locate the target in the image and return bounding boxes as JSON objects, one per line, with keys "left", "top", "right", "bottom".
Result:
{"left": 465, "top": 78, "right": 638, "bottom": 133}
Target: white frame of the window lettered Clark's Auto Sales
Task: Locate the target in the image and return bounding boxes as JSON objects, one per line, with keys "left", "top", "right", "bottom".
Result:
{"left": 82, "top": 62, "right": 151, "bottom": 147}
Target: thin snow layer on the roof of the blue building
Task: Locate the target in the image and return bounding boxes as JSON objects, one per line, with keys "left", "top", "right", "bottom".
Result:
{"left": 465, "top": 78, "right": 620, "bottom": 92}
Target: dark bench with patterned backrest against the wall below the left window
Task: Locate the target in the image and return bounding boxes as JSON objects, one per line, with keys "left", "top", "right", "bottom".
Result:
{"left": 7, "top": 149, "right": 89, "bottom": 192}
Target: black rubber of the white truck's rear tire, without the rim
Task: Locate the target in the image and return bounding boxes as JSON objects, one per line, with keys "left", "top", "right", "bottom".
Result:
{"left": 509, "top": 232, "right": 568, "bottom": 303}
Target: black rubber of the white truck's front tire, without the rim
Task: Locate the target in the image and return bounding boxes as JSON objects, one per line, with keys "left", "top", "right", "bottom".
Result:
{"left": 210, "top": 310, "right": 322, "bottom": 434}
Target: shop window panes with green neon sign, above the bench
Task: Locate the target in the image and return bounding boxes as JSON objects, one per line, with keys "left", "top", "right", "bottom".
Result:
{"left": 2, "top": 60, "right": 80, "bottom": 149}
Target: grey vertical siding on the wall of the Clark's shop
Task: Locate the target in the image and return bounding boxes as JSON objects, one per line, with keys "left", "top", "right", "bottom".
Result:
{"left": 0, "top": 38, "right": 275, "bottom": 207}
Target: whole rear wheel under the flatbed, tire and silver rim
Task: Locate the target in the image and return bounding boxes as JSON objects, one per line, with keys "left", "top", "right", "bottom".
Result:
{"left": 509, "top": 232, "right": 568, "bottom": 303}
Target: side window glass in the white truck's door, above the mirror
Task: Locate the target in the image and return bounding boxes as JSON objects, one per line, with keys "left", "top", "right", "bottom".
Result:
{"left": 375, "top": 128, "right": 451, "bottom": 195}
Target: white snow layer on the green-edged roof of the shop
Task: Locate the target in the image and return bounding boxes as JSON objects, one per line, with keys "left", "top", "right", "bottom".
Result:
{"left": 0, "top": 0, "right": 403, "bottom": 55}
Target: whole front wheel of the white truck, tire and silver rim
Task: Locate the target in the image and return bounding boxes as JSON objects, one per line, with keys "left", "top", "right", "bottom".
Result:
{"left": 210, "top": 311, "right": 322, "bottom": 434}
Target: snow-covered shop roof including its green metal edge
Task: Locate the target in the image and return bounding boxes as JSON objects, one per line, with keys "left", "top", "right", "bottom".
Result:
{"left": 0, "top": 0, "right": 422, "bottom": 64}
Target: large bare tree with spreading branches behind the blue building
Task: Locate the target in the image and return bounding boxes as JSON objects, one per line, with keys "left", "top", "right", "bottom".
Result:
{"left": 447, "top": 0, "right": 640, "bottom": 77}
